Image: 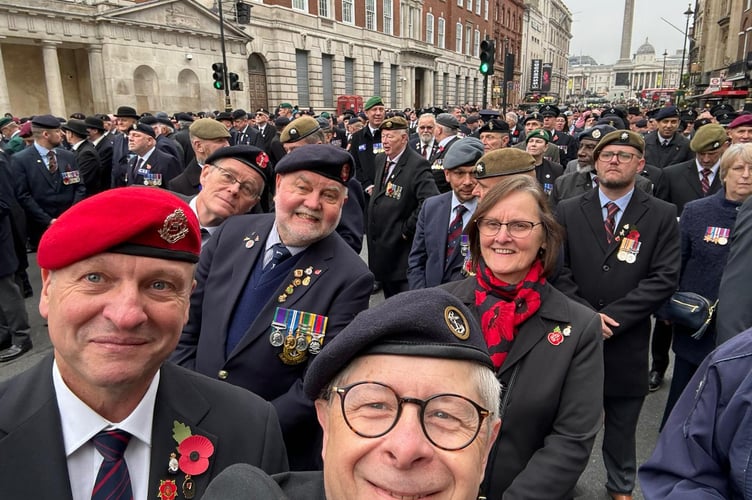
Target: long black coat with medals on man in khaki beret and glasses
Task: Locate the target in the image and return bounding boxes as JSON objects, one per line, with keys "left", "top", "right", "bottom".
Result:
{"left": 554, "top": 189, "right": 681, "bottom": 397}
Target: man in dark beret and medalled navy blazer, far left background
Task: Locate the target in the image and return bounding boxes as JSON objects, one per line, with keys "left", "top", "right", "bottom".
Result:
{"left": 10, "top": 115, "right": 86, "bottom": 248}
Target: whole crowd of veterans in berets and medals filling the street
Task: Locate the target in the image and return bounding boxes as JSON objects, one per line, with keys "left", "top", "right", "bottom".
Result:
{"left": 0, "top": 96, "right": 752, "bottom": 500}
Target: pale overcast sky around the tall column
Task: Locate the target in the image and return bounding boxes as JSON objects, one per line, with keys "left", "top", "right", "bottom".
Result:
{"left": 564, "top": 0, "right": 695, "bottom": 64}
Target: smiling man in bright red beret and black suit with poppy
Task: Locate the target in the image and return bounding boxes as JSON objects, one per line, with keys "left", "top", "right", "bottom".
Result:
{"left": 0, "top": 187, "right": 287, "bottom": 499}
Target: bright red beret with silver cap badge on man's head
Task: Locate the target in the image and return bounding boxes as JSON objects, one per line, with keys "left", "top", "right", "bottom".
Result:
{"left": 37, "top": 186, "right": 201, "bottom": 270}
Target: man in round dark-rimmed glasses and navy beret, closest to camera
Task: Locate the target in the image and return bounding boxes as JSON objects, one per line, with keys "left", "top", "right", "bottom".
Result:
{"left": 204, "top": 288, "right": 501, "bottom": 500}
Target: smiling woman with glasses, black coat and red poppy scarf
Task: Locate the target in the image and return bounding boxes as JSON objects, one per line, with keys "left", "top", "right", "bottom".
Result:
{"left": 442, "top": 175, "right": 603, "bottom": 500}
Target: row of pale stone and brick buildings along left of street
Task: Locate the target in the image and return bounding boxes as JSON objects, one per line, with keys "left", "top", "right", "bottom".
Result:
{"left": 0, "top": 0, "right": 522, "bottom": 116}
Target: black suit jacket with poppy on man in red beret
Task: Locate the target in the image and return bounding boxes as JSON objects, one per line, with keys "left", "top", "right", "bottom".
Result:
{"left": 0, "top": 356, "right": 287, "bottom": 500}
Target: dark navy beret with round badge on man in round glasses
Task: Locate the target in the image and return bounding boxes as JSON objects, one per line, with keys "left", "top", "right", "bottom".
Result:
{"left": 296, "top": 288, "right": 493, "bottom": 399}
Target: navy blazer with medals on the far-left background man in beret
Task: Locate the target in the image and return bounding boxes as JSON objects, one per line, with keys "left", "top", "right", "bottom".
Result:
{"left": 10, "top": 145, "right": 86, "bottom": 227}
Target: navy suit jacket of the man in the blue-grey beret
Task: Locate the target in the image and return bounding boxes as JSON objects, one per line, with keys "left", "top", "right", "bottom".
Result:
{"left": 407, "top": 192, "right": 472, "bottom": 290}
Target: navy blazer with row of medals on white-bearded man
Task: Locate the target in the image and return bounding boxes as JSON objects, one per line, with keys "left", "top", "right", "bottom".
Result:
{"left": 172, "top": 214, "right": 373, "bottom": 468}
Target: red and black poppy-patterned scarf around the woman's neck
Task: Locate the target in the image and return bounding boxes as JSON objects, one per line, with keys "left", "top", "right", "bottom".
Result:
{"left": 475, "top": 259, "right": 546, "bottom": 370}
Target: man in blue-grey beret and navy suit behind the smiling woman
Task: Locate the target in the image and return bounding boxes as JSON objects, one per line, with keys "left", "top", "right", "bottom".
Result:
{"left": 407, "top": 137, "right": 483, "bottom": 290}
